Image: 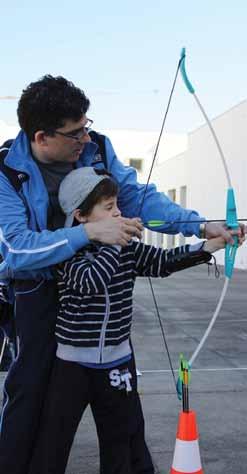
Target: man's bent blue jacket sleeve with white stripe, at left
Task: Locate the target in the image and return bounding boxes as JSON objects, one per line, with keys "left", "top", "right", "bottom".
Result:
{"left": 0, "top": 173, "right": 88, "bottom": 278}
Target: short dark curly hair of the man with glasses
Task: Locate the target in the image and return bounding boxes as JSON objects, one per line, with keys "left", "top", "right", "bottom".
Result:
{"left": 17, "top": 75, "right": 90, "bottom": 140}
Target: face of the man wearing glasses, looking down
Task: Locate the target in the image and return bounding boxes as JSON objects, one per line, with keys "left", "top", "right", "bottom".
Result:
{"left": 34, "top": 115, "right": 91, "bottom": 163}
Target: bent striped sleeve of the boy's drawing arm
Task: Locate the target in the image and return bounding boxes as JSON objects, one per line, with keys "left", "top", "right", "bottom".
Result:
{"left": 58, "top": 246, "right": 119, "bottom": 295}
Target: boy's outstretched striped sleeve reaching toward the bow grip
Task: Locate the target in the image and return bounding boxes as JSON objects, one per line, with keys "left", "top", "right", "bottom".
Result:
{"left": 133, "top": 242, "right": 212, "bottom": 277}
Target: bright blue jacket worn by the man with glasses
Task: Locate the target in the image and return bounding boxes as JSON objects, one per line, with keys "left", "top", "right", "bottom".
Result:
{"left": 0, "top": 131, "right": 200, "bottom": 280}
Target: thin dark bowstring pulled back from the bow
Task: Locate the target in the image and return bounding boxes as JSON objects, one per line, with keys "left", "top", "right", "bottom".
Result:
{"left": 138, "top": 54, "right": 181, "bottom": 392}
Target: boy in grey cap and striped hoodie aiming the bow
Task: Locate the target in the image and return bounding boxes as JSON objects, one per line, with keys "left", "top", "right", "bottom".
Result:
{"left": 30, "top": 167, "right": 224, "bottom": 474}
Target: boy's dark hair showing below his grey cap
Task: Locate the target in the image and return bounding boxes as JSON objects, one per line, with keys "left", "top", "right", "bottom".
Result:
{"left": 73, "top": 169, "right": 118, "bottom": 225}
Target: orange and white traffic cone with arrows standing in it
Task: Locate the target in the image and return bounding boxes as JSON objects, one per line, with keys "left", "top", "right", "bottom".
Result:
{"left": 170, "top": 411, "right": 203, "bottom": 474}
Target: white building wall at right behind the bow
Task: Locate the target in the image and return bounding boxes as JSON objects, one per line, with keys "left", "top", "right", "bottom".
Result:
{"left": 152, "top": 101, "right": 247, "bottom": 268}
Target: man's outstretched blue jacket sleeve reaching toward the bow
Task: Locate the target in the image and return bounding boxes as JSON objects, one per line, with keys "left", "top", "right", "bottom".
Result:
{"left": 105, "top": 138, "right": 203, "bottom": 236}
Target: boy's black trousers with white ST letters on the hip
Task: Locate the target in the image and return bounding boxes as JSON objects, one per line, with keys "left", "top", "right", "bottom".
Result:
{"left": 29, "top": 359, "right": 141, "bottom": 474}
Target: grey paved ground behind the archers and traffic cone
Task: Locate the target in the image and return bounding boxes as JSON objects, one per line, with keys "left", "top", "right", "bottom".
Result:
{"left": 1, "top": 267, "right": 247, "bottom": 474}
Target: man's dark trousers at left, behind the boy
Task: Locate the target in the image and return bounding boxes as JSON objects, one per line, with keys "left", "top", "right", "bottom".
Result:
{"left": 0, "top": 280, "right": 57, "bottom": 474}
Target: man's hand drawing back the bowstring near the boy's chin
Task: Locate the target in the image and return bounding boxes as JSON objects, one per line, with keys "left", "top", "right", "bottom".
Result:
{"left": 84, "top": 217, "right": 143, "bottom": 247}
